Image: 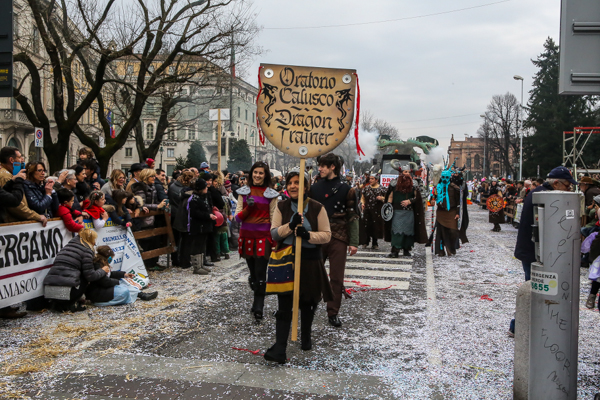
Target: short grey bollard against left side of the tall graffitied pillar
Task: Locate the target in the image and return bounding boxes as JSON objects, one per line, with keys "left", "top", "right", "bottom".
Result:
{"left": 513, "top": 281, "right": 531, "bottom": 400}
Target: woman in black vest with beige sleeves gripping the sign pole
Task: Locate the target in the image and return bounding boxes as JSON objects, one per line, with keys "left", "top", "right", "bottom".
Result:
{"left": 264, "top": 169, "right": 333, "bottom": 364}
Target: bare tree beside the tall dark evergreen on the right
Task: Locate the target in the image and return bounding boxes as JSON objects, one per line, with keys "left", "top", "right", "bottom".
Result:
{"left": 477, "top": 93, "right": 520, "bottom": 177}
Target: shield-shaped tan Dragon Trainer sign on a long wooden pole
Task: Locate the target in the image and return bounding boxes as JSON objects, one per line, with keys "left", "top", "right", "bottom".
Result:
{"left": 256, "top": 64, "right": 360, "bottom": 341}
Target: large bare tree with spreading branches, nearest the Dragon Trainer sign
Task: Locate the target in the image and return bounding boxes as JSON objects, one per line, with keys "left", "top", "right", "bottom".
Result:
{"left": 70, "top": 0, "right": 257, "bottom": 173}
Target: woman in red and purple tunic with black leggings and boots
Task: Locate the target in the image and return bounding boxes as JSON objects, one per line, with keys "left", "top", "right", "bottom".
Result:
{"left": 235, "top": 161, "right": 279, "bottom": 321}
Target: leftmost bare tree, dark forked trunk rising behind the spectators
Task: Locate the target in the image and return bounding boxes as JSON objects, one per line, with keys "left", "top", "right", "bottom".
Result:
{"left": 13, "top": 0, "right": 133, "bottom": 171}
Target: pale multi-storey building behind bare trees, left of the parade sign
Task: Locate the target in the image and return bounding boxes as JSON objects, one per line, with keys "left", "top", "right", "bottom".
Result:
{"left": 111, "top": 74, "right": 284, "bottom": 175}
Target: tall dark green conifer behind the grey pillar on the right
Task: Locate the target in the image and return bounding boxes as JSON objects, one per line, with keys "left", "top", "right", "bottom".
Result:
{"left": 523, "top": 38, "right": 600, "bottom": 176}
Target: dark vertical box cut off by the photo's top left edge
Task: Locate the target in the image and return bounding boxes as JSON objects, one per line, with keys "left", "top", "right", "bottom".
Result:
{"left": 0, "top": 0, "right": 13, "bottom": 97}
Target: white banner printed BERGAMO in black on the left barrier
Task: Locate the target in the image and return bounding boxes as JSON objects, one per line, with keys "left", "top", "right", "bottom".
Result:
{"left": 0, "top": 220, "right": 73, "bottom": 307}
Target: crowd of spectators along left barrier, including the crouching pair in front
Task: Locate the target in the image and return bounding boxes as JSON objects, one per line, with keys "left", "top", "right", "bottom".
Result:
{"left": 0, "top": 147, "right": 251, "bottom": 318}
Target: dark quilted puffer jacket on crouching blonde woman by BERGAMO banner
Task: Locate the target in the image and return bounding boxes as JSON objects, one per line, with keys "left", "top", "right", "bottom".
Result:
{"left": 44, "top": 236, "right": 106, "bottom": 287}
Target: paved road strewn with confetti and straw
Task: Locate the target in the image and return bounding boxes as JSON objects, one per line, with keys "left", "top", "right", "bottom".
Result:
{"left": 0, "top": 206, "right": 600, "bottom": 399}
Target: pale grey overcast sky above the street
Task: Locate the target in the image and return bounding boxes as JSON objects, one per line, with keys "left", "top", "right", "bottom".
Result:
{"left": 247, "top": 0, "right": 560, "bottom": 153}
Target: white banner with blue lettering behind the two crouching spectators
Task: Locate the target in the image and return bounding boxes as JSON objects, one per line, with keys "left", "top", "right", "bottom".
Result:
{"left": 83, "top": 219, "right": 149, "bottom": 289}
